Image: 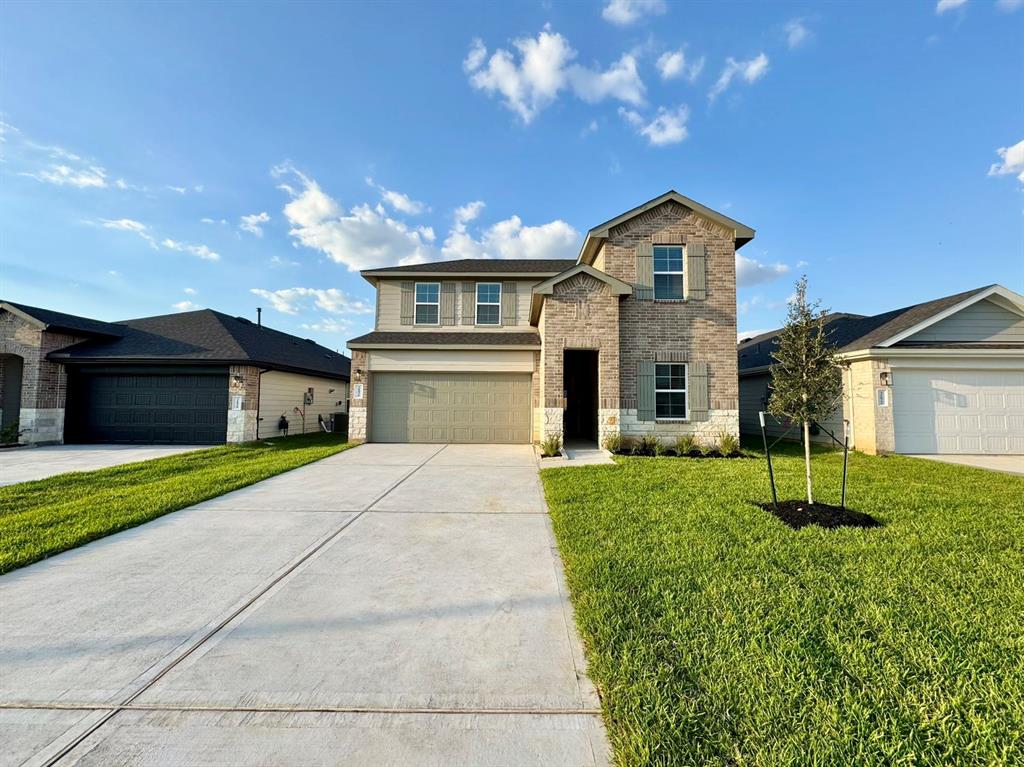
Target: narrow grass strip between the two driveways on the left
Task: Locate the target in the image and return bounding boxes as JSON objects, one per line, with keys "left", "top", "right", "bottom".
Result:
{"left": 0, "top": 434, "right": 351, "bottom": 573}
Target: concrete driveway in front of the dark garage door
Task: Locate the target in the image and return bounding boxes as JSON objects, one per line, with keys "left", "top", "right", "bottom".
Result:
{"left": 0, "top": 444, "right": 210, "bottom": 485}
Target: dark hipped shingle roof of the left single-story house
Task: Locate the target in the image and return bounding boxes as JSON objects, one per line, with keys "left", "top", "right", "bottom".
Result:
{"left": 50, "top": 309, "right": 350, "bottom": 378}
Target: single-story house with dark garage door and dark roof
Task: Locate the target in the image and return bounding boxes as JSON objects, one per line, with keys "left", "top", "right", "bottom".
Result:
{"left": 0, "top": 301, "right": 349, "bottom": 444}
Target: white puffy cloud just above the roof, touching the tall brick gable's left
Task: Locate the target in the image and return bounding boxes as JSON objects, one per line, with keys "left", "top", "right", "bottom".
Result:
{"left": 441, "top": 211, "right": 580, "bottom": 259}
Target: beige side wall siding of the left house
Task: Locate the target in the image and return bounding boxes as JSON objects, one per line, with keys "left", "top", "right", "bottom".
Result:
{"left": 259, "top": 371, "right": 348, "bottom": 438}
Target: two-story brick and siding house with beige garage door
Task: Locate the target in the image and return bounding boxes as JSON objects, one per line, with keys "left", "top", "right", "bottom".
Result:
{"left": 348, "top": 191, "right": 754, "bottom": 442}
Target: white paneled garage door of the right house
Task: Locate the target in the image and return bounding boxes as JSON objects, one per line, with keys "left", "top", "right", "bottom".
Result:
{"left": 893, "top": 369, "right": 1024, "bottom": 455}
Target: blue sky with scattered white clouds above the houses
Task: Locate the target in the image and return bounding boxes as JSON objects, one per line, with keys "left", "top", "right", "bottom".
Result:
{"left": 0, "top": 0, "right": 1024, "bottom": 348}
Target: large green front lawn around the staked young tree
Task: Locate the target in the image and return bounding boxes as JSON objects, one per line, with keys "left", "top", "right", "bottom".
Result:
{"left": 542, "top": 448, "right": 1024, "bottom": 767}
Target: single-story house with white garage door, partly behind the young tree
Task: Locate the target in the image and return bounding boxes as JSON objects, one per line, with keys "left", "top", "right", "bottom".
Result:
{"left": 738, "top": 285, "right": 1024, "bottom": 455}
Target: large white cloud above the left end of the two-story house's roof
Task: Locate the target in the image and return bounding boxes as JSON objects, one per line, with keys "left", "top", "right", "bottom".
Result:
{"left": 272, "top": 164, "right": 433, "bottom": 271}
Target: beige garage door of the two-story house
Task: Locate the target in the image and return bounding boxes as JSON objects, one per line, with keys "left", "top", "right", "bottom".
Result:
{"left": 369, "top": 373, "right": 530, "bottom": 443}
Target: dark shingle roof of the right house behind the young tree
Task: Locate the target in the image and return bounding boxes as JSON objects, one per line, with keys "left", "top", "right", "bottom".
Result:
{"left": 736, "top": 285, "right": 992, "bottom": 371}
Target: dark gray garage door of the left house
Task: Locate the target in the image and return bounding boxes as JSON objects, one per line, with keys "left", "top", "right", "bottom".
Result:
{"left": 68, "top": 368, "right": 227, "bottom": 444}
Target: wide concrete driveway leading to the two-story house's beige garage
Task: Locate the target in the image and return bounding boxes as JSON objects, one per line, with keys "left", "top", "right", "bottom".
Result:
{"left": 0, "top": 444, "right": 607, "bottom": 765}
